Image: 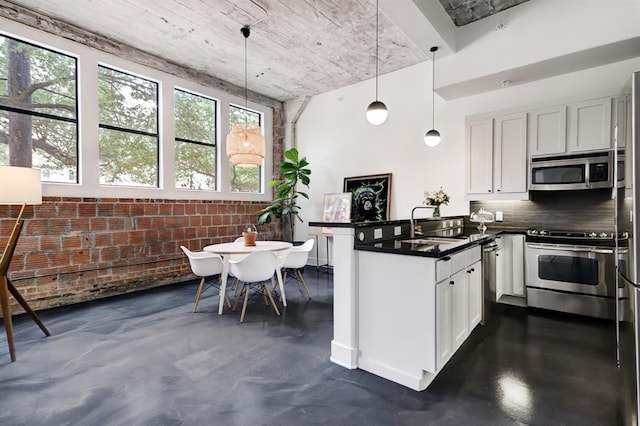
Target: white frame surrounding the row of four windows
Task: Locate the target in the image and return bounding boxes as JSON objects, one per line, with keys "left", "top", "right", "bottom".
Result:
{"left": 0, "top": 17, "right": 274, "bottom": 202}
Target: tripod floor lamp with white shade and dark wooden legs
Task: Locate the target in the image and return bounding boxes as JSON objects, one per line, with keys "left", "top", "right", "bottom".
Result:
{"left": 0, "top": 166, "right": 50, "bottom": 362}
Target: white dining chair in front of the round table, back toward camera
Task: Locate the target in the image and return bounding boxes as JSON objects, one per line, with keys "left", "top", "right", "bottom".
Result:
{"left": 229, "top": 251, "right": 280, "bottom": 322}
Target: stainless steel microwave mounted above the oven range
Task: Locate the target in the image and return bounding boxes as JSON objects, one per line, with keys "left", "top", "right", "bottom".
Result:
{"left": 529, "top": 150, "right": 624, "bottom": 191}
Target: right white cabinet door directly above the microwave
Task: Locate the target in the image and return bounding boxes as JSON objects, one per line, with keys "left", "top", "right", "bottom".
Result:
{"left": 567, "top": 97, "right": 613, "bottom": 152}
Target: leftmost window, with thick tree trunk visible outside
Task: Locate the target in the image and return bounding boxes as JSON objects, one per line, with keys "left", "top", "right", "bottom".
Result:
{"left": 0, "top": 36, "right": 78, "bottom": 183}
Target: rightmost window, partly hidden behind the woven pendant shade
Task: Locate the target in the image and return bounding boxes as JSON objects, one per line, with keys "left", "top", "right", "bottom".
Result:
{"left": 229, "top": 105, "right": 262, "bottom": 193}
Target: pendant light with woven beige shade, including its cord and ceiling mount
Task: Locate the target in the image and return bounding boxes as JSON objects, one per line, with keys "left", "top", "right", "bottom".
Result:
{"left": 227, "top": 25, "right": 266, "bottom": 166}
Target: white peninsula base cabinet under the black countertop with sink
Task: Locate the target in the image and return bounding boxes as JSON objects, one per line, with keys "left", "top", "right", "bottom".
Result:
{"left": 353, "top": 246, "right": 482, "bottom": 390}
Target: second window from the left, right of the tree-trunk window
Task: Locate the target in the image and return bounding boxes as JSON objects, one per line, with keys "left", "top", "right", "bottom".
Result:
{"left": 98, "top": 66, "right": 159, "bottom": 187}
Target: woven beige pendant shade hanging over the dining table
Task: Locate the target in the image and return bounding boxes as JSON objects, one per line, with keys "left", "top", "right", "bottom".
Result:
{"left": 227, "top": 124, "right": 266, "bottom": 166}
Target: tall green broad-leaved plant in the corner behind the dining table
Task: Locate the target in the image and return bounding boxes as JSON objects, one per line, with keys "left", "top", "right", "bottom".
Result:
{"left": 256, "top": 148, "right": 311, "bottom": 241}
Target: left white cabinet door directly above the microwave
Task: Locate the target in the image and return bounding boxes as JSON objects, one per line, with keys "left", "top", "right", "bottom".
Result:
{"left": 527, "top": 105, "right": 567, "bottom": 155}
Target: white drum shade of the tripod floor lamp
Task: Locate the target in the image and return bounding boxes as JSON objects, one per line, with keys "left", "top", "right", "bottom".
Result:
{"left": 0, "top": 166, "right": 42, "bottom": 204}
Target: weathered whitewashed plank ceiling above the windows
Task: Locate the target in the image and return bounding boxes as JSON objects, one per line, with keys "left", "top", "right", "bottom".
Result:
{"left": 3, "top": 0, "right": 523, "bottom": 101}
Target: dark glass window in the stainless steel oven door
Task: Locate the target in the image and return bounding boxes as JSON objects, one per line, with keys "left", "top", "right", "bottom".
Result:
{"left": 538, "top": 255, "right": 598, "bottom": 286}
